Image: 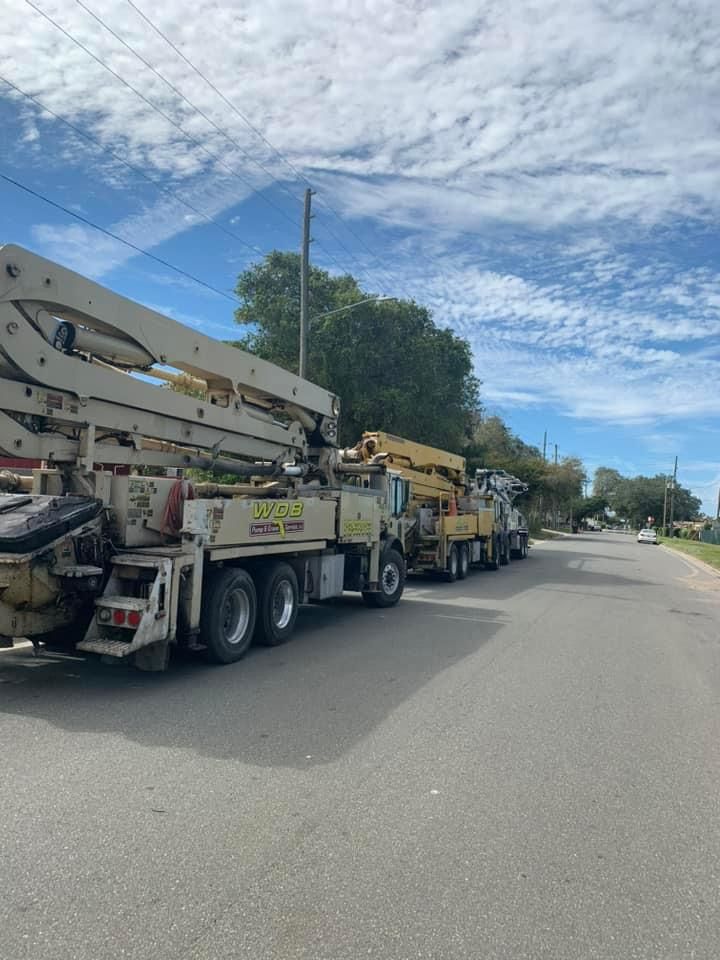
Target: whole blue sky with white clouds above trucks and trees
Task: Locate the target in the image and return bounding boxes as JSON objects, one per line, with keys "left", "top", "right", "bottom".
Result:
{"left": 0, "top": 0, "right": 720, "bottom": 515}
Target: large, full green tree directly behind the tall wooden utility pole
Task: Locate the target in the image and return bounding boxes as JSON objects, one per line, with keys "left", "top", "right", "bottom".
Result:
{"left": 235, "top": 251, "right": 479, "bottom": 450}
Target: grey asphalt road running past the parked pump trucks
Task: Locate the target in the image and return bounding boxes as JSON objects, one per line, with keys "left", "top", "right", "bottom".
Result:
{"left": 0, "top": 534, "right": 720, "bottom": 960}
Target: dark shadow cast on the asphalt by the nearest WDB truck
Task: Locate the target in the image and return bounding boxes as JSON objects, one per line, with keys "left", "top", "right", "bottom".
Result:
{"left": 0, "top": 597, "right": 505, "bottom": 768}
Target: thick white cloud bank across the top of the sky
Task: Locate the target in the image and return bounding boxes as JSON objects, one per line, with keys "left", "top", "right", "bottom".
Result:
{"left": 0, "top": 0, "right": 720, "bottom": 226}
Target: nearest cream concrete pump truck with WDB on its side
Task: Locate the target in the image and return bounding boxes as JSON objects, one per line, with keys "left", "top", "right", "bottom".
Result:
{"left": 0, "top": 245, "right": 405, "bottom": 669}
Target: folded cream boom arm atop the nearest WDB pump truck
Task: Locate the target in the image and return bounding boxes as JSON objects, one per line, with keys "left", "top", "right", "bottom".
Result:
{"left": 0, "top": 245, "right": 339, "bottom": 484}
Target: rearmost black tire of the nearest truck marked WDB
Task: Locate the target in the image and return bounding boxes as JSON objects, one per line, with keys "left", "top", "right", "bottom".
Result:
{"left": 200, "top": 567, "right": 257, "bottom": 663}
